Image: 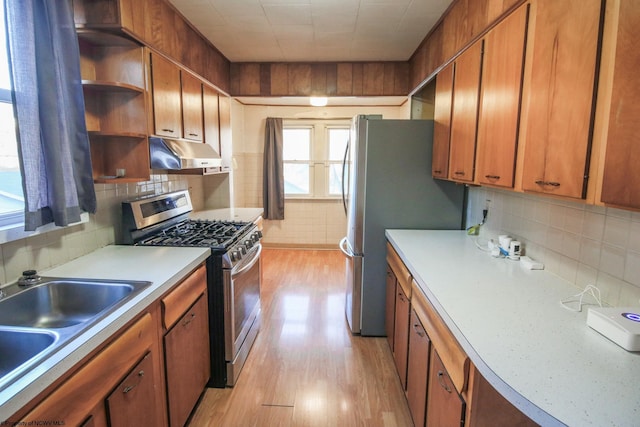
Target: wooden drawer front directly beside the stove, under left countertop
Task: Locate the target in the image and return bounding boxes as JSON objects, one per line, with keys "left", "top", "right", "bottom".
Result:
{"left": 162, "top": 264, "right": 207, "bottom": 329}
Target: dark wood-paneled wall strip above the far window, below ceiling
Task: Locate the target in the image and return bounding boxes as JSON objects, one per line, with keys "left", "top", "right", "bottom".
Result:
{"left": 230, "top": 62, "right": 409, "bottom": 96}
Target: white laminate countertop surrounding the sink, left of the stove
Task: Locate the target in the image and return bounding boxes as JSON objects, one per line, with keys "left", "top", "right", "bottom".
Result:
{"left": 0, "top": 246, "right": 211, "bottom": 425}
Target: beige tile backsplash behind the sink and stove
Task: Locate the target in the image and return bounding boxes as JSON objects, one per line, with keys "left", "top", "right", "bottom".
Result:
{"left": 0, "top": 174, "right": 203, "bottom": 285}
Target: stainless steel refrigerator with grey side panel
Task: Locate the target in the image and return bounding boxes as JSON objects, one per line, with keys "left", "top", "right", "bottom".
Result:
{"left": 340, "top": 115, "right": 465, "bottom": 336}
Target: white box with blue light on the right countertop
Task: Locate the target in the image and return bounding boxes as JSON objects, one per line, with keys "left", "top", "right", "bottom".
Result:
{"left": 587, "top": 307, "right": 640, "bottom": 351}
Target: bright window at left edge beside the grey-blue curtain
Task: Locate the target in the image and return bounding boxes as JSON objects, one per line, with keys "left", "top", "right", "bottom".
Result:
{"left": 0, "top": 1, "right": 24, "bottom": 227}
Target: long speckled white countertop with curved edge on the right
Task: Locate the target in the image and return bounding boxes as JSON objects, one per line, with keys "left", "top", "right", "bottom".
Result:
{"left": 386, "top": 230, "right": 640, "bottom": 427}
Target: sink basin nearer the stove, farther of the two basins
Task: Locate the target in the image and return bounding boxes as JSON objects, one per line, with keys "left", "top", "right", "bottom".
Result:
{"left": 0, "top": 280, "right": 135, "bottom": 328}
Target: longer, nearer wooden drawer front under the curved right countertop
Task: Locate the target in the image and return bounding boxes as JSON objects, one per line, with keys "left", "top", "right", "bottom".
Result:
{"left": 411, "top": 281, "right": 469, "bottom": 393}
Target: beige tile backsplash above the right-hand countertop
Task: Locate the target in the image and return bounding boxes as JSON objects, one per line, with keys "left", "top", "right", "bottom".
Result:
{"left": 467, "top": 187, "right": 640, "bottom": 306}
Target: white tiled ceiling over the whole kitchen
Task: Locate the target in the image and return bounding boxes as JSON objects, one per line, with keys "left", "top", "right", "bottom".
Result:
{"left": 170, "top": 0, "right": 452, "bottom": 62}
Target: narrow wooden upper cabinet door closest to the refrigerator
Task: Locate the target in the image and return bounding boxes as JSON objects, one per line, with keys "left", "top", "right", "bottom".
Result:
{"left": 431, "top": 63, "right": 454, "bottom": 179}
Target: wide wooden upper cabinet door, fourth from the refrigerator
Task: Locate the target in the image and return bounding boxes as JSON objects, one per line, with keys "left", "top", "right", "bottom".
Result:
{"left": 521, "top": 0, "right": 603, "bottom": 199}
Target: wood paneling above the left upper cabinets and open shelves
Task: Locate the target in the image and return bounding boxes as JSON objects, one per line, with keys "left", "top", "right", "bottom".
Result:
{"left": 70, "top": 0, "right": 230, "bottom": 93}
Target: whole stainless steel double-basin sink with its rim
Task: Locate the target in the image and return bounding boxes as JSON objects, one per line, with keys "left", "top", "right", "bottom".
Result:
{"left": 0, "top": 276, "right": 151, "bottom": 391}
